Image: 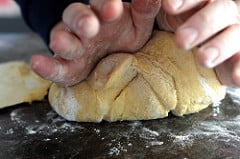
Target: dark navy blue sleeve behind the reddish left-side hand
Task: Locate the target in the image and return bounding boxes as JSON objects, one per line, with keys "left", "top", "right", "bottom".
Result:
{"left": 16, "top": 0, "right": 88, "bottom": 44}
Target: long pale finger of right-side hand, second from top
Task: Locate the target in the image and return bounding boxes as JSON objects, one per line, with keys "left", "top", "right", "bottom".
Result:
{"left": 176, "top": 0, "right": 238, "bottom": 50}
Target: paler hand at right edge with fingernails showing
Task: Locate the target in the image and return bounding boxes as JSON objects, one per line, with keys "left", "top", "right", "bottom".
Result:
{"left": 157, "top": 0, "right": 240, "bottom": 86}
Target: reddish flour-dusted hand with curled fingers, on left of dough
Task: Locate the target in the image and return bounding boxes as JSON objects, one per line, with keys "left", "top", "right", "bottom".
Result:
{"left": 31, "top": 0, "right": 161, "bottom": 86}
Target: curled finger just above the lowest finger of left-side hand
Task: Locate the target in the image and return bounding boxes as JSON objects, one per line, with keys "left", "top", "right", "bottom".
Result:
{"left": 49, "top": 23, "right": 84, "bottom": 60}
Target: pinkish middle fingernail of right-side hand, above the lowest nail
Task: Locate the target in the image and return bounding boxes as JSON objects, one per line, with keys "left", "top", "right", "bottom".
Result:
{"left": 181, "top": 28, "right": 198, "bottom": 50}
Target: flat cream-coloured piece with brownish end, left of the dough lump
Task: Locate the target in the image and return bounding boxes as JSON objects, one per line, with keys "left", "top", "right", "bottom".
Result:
{"left": 0, "top": 61, "right": 51, "bottom": 108}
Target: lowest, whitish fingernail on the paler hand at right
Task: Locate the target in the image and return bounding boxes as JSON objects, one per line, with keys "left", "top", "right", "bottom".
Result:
{"left": 202, "top": 47, "right": 219, "bottom": 68}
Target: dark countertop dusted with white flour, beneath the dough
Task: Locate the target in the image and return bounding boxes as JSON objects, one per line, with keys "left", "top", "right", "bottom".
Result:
{"left": 0, "top": 34, "right": 240, "bottom": 159}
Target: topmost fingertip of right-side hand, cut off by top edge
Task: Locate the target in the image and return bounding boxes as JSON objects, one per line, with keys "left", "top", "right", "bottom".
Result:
{"left": 162, "top": 0, "right": 209, "bottom": 14}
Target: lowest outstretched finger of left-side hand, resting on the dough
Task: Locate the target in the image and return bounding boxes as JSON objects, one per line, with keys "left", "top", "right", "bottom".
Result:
{"left": 30, "top": 55, "right": 89, "bottom": 86}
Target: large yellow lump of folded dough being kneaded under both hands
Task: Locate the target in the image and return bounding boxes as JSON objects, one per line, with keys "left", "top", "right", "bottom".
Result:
{"left": 49, "top": 32, "right": 225, "bottom": 122}
